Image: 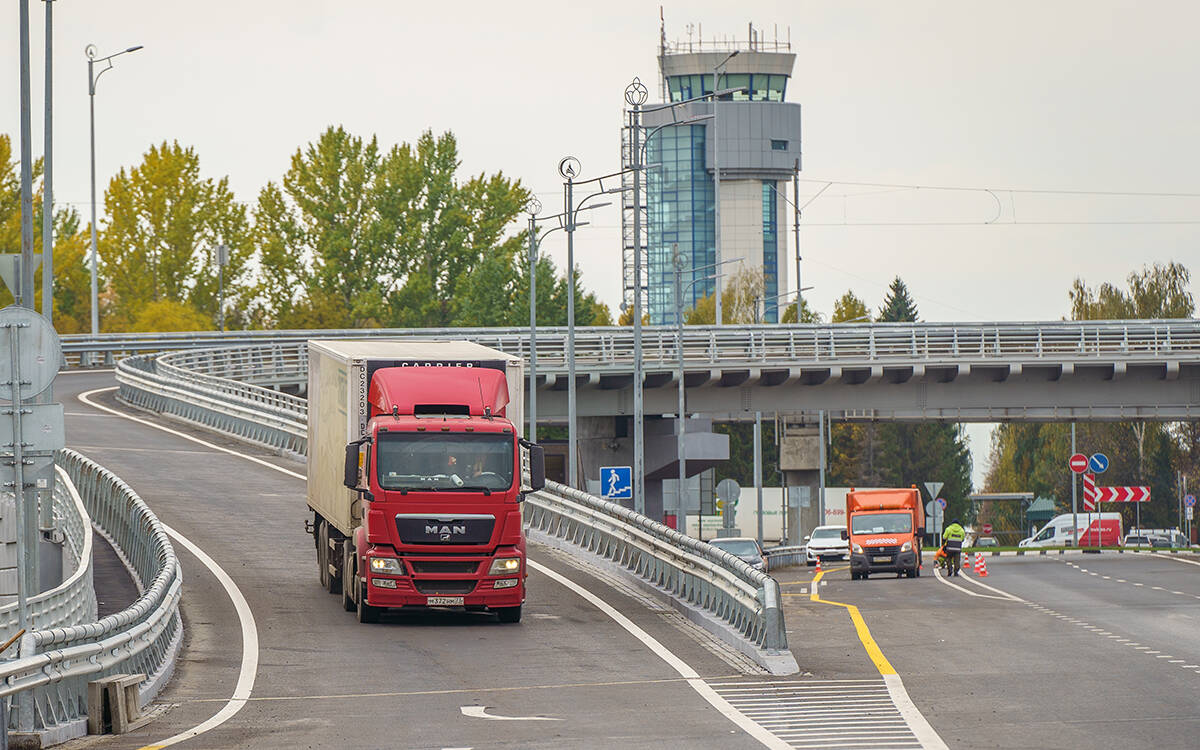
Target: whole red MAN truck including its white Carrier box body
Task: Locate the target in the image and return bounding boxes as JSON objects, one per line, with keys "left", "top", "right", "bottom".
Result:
{"left": 307, "top": 340, "right": 545, "bottom": 623}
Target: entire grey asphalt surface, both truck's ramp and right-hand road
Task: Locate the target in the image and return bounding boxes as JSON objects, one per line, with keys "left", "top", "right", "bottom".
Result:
{"left": 55, "top": 373, "right": 1200, "bottom": 749}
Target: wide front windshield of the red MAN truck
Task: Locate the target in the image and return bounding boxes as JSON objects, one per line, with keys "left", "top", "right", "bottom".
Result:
{"left": 376, "top": 432, "right": 514, "bottom": 492}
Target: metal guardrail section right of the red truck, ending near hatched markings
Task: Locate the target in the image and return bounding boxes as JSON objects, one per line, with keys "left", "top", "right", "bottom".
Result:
{"left": 524, "top": 482, "right": 787, "bottom": 653}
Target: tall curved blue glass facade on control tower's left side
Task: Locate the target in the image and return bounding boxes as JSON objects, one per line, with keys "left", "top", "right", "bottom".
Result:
{"left": 646, "top": 125, "right": 716, "bottom": 325}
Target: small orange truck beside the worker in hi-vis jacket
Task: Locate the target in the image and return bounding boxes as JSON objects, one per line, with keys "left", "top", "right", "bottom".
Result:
{"left": 842, "top": 487, "right": 925, "bottom": 581}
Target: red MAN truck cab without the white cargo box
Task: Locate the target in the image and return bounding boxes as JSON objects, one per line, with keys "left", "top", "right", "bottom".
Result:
{"left": 346, "top": 367, "right": 545, "bottom": 623}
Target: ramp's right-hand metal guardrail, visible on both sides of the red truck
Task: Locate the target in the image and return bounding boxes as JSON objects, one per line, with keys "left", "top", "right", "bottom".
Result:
{"left": 116, "top": 349, "right": 787, "bottom": 652}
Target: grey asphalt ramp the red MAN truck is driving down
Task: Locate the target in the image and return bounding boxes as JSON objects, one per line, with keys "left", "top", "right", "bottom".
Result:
{"left": 55, "top": 373, "right": 761, "bottom": 749}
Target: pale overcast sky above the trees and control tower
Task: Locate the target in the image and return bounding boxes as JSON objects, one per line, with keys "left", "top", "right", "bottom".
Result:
{"left": 0, "top": 0, "right": 1200, "bottom": 484}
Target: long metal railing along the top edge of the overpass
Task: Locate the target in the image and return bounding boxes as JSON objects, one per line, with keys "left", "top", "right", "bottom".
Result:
{"left": 62, "top": 319, "right": 1200, "bottom": 374}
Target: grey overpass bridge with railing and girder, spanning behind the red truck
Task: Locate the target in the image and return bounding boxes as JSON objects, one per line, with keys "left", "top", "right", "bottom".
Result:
{"left": 64, "top": 319, "right": 1200, "bottom": 424}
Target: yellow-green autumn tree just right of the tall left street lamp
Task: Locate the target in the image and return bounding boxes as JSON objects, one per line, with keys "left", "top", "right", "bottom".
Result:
{"left": 101, "top": 142, "right": 250, "bottom": 328}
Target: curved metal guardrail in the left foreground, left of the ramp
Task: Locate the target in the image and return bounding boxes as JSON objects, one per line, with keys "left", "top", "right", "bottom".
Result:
{"left": 0, "top": 450, "right": 184, "bottom": 739}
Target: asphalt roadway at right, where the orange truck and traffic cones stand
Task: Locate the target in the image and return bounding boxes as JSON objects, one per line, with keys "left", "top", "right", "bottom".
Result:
{"left": 776, "top": 553, "right": 1200, "bottom": 749}
